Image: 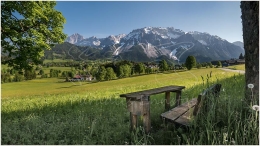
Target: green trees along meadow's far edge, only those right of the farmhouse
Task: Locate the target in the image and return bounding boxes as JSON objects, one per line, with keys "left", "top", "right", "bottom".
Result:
{"left": 92, "top": 56, "right": 221, "bottom": 81}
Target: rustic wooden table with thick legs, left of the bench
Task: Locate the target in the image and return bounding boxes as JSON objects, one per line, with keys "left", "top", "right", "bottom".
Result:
{"left": 120, "top": 86, "right": 185, "bottom": 133}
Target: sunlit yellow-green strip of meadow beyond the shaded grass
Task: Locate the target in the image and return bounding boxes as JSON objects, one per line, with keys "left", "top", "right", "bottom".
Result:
{"left": 1, "top": 67, "right": 241, "bottom": 98}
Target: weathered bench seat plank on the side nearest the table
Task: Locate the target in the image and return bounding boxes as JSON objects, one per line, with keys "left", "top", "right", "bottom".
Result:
{"left": 161, "top": 98, "right": 197, "bottom": 121}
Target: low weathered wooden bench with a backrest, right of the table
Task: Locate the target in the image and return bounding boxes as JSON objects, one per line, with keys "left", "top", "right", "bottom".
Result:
{"left": 161, "top": 84, "right": 221, "bottom": 126}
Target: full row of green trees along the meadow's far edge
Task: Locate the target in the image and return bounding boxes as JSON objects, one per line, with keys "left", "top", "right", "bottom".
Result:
{"left": 2, "top": 56, "right": 221, "bottom": 82}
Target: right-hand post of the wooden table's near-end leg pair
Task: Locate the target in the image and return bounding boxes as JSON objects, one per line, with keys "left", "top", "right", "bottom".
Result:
{"left": 143, "top": 101, "right": 151, "bottom": 133}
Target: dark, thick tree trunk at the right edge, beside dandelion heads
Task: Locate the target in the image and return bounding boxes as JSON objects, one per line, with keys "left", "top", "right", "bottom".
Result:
{"left": 240, "top": 1, "right": 259, "bottom": 105}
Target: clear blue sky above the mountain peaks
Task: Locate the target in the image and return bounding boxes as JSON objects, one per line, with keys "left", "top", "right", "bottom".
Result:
{"left": 55, "top": 1, "right": 243, "bottom": 42}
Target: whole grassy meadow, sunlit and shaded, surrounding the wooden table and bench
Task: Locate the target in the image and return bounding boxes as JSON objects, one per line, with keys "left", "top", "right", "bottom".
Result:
{"left": 1, "top": 68, "right": 259, "bottom": 145}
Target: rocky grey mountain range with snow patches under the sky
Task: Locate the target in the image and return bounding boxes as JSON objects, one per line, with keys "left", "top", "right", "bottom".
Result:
{"left": 49, "top": 27, "right": 244, "bottom": 62}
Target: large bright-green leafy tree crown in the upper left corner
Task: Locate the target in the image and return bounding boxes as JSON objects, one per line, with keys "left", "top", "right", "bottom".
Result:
{"left": 1, "top": 1, "right": 66, "bottom": 70}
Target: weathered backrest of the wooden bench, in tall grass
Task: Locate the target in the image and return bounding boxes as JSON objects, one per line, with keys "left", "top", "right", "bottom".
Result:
{"left": 193, "top": 84, "right": 221, "bottom": 116}
